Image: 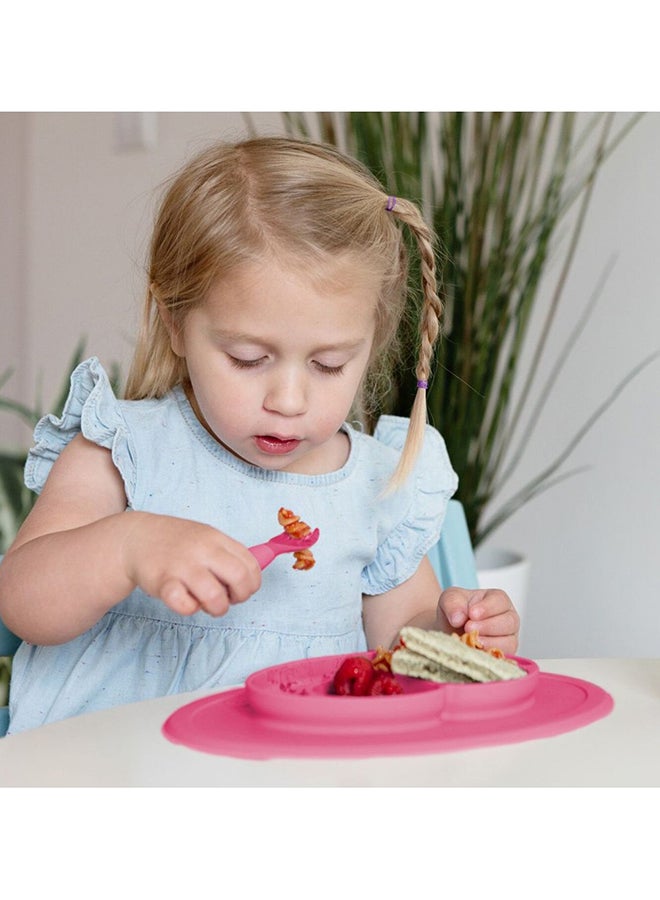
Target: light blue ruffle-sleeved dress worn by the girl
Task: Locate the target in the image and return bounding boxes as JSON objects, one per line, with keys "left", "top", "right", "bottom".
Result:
{"left": 10, "top": 358, "right": 457, "bottom": 733}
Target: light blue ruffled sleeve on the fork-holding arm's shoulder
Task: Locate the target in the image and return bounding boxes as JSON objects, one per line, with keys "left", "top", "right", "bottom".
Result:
{"left": 25, "top": 357, "right": 136, "bottom": 504}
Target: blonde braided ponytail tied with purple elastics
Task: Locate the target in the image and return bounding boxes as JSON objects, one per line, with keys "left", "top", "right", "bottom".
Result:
{"left": 386, "top": 197, "right": 442, "bottom": 491}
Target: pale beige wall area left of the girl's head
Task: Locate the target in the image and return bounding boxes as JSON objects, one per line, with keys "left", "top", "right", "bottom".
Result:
{"left": 12, "top": 113, "right": 278, "bottom": 398}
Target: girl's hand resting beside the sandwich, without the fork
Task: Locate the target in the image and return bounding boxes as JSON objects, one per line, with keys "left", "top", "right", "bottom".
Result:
{"left": 438, "top": 587, "right": 520, "bottom": 656}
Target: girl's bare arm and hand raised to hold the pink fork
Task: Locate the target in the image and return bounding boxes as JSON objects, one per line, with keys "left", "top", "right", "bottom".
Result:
{"left": 0, "top": 436, "right": 261, "bottom": 644}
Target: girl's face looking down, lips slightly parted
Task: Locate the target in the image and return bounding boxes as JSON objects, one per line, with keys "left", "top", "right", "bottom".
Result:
{"left": 170, "top": 253, "right": 378, "bottom": 474}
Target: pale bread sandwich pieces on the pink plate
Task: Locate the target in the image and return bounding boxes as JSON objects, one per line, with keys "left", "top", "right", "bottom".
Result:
{"left": 392, "top": 626, "right": 527, "bottom": 683}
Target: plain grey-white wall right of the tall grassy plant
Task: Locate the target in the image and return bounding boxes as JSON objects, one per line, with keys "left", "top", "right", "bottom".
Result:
{"left": 480, "top": 114, "right": 660, "bottom": 657}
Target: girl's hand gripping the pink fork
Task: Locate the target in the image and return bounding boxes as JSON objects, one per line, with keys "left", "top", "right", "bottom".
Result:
{"left": 121, "top": 512, "right": 261, "bottom": 616}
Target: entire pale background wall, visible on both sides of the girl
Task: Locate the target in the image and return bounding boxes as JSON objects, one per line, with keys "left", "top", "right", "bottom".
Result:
{"left": 0, "top": 113, "right": 660, "bottom": 657}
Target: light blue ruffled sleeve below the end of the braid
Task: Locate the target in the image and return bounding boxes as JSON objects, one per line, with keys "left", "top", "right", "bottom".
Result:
{"left": 362, "top": 416, "right": 458, "bottom": 595}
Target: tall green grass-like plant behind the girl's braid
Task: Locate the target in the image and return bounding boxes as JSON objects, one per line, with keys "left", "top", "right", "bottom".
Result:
{"left": 285, "top": 112, "right": 652, "bottom": 546}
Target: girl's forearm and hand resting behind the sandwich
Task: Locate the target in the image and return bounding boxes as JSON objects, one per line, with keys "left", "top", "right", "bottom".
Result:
{"left": 362, "top": 557, "right": 520, "bottom": 654}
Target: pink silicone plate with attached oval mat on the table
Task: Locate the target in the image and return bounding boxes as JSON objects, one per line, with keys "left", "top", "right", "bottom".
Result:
{"left": 163, "top": 654, "right": 613, "bottom": 759}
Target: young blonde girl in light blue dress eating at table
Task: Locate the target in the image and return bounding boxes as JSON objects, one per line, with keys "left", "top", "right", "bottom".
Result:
{"left": 0, "top": 138, "right": 519, "bottom": 732}
